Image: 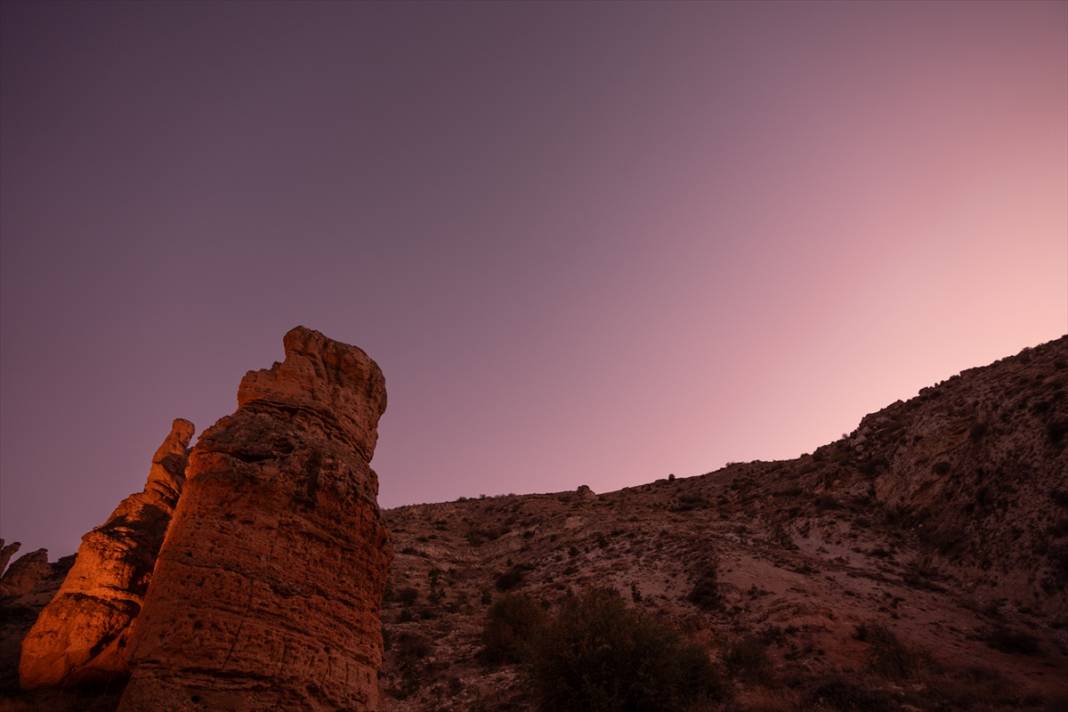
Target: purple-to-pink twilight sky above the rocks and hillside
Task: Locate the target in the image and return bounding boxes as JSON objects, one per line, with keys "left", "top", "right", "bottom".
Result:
{"left": 0, "top": 1, "right": 1068, "bottom": 557}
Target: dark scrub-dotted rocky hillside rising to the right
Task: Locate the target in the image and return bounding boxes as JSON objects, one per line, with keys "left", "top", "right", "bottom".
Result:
{"left": 381, "top": 337, "right": 1068, "bottom": 712}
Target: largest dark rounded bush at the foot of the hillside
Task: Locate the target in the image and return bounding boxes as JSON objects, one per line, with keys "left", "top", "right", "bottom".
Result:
{"left": 530, "top": 589, "right": 725, "bottom": 712}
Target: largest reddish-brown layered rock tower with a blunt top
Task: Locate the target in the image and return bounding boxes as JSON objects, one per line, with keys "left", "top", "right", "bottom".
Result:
{"left": 120, "top": 327, "right": 392, "bottom": 712}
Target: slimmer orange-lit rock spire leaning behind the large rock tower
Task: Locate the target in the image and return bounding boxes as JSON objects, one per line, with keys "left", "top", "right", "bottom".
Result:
{"left": 19, "top": 418, "right": 193, "bottom": 690}
